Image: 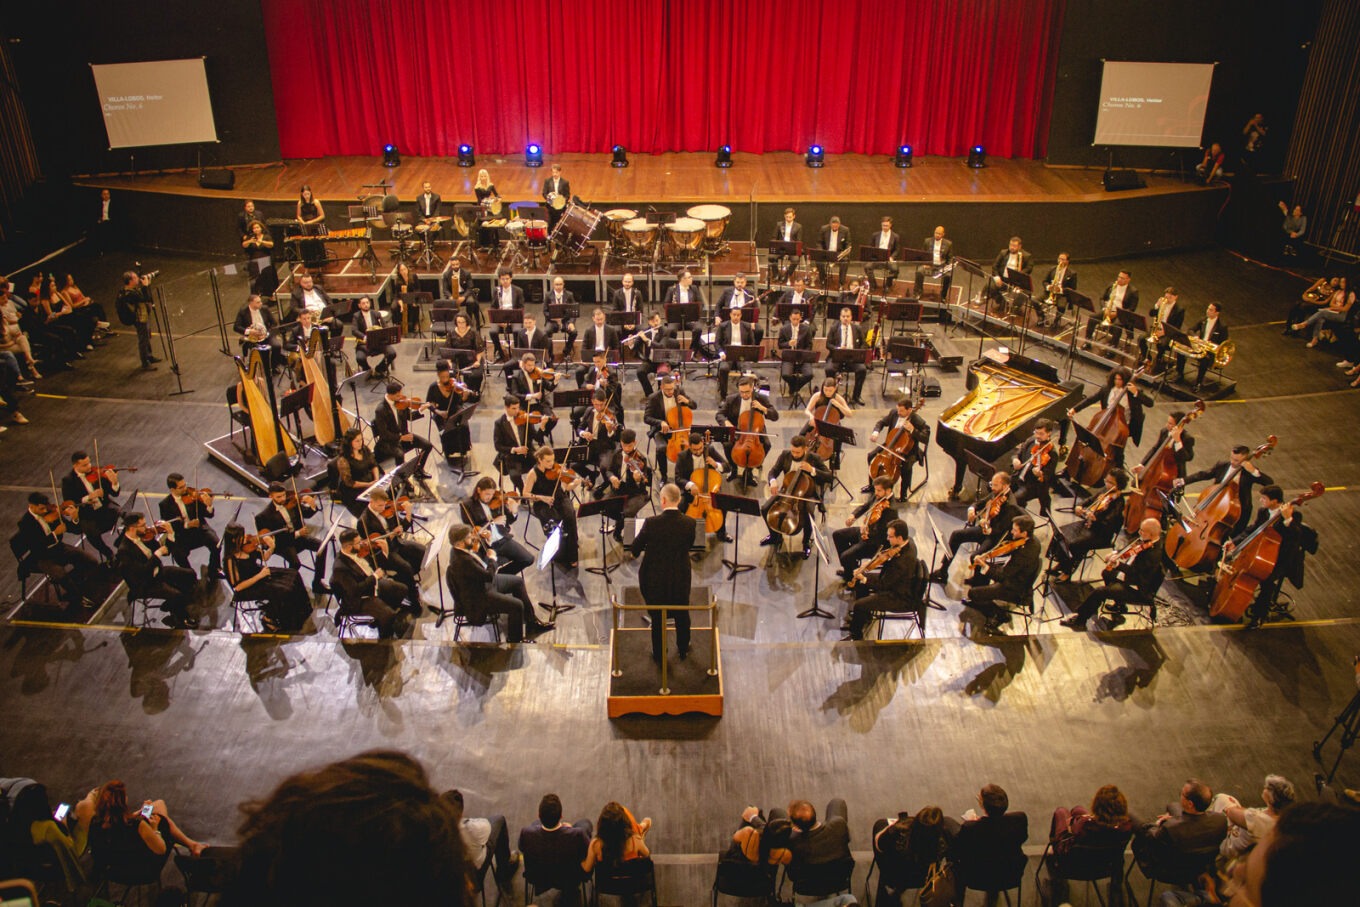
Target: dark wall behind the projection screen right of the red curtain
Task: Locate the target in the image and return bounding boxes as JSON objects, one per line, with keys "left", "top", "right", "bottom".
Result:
{"left": 1047, "top": 0, "right": 1322, "bottom": 173}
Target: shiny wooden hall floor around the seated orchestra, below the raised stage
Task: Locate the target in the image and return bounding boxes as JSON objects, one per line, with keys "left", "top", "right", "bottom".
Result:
{"left": 0, "top": 239, "right": 1360, "bottom": 904}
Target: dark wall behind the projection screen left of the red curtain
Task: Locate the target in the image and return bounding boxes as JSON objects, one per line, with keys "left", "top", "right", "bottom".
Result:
{"left": 4, "top": 0, "right": 279, "bottom": 181}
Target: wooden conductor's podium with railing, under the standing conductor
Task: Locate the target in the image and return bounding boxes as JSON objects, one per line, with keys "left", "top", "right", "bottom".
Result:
{"left": 608, "top": 586, "right": 722, "bottom": 718}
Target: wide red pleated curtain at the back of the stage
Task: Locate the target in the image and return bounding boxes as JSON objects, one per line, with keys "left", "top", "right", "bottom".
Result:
{"left": 262, "top": 0, "right": 1064, "bottom": 158}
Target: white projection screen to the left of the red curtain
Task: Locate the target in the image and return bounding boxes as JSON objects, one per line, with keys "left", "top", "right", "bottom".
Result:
{"left": 90, "top": 57, "right": 218, "bottom": 150}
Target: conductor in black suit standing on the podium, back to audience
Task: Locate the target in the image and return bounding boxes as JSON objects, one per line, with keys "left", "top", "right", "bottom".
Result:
{"left": 632, "top": 484, "right": 695, "bottom": 664}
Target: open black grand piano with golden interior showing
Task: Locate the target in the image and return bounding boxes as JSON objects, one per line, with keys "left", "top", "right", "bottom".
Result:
{"left": 936, "top": 349, "right": 1083, "bottom": 495}
